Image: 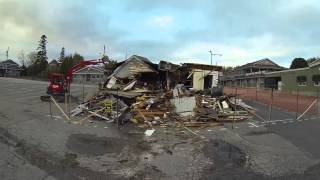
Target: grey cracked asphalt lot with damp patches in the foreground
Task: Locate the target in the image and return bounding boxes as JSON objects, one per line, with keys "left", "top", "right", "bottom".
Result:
{"left": 0, "top": 78, "right": 320, "bottom": 179}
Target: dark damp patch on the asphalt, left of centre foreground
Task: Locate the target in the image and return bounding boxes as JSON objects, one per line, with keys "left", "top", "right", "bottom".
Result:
{"left": 67, "top": 134, "right": 127, "bottom": 156}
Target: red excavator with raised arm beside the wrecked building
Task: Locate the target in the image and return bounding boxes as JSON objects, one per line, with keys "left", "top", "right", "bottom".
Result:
{"left": 40, "top": 59, "right": 105, "bottom": 101}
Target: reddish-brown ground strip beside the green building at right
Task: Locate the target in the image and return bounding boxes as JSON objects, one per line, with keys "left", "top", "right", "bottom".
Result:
{"left": 224, "top": 86, "right": 320, "bottom": 121}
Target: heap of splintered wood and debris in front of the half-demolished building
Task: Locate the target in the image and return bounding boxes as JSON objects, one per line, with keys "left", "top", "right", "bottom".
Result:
{"left": 71, "top": 86, "right": 253, "bottom": 127}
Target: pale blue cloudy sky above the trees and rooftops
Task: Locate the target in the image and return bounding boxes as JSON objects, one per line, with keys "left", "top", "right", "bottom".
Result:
{"left": 0, "top": 0, "right": 320, "bottom": 67}
